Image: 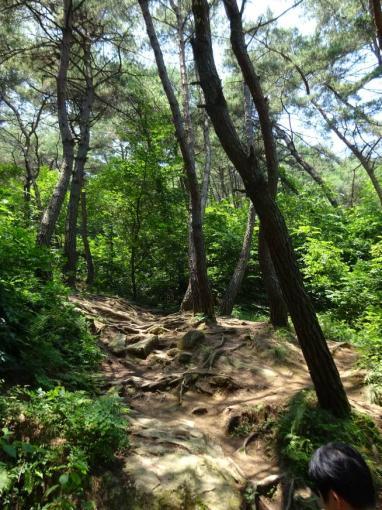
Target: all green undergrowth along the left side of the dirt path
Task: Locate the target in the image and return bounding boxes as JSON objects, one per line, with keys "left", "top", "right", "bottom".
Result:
{"left": 0, "top": 211, "right": 127, "bottom": 510}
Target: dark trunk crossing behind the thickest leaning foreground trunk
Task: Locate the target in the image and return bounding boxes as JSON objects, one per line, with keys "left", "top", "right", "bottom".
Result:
{"left": 224, "top": 14, "right": 288, "bottom": 327}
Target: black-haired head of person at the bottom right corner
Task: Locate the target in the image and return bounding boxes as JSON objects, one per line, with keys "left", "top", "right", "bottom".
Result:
{"left": 309, "top": 443, "right": 376, "bottom": 510}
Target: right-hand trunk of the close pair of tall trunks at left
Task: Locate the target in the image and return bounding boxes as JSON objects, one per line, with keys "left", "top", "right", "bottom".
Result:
{"left": 64, "top": 51, "right": 94, "bottom": 287}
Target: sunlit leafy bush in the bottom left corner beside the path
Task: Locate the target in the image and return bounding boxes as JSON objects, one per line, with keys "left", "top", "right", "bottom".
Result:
{"left": 0, "top": 387, "right": 127, "bottom": 510}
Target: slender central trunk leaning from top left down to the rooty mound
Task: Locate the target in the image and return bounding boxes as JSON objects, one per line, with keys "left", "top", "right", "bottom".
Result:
{"left": 139, "top": 0, "right": 215, "bottom": 318}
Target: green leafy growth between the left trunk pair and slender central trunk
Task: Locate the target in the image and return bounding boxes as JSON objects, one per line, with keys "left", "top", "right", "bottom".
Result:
{"left": 88, "top": 135, "right": 187, "bottom": 305}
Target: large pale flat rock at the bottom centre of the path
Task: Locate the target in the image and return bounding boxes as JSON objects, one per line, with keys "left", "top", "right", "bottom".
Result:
{"left": 124, "top": 417, "right": 245, "bottom": 510}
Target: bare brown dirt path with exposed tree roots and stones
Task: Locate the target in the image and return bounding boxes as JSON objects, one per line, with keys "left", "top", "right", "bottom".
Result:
{"left": 72, "top": 296, "right": 382, "bottom": 510}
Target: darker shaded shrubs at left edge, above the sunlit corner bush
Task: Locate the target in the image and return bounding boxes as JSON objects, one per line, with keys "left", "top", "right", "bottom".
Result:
{"left": 0, "top": 203, "right": 100, "bottom": 387}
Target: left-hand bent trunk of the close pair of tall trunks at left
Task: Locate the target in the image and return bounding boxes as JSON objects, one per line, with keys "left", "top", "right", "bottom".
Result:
{"left": 37, "top": 0, "right": 74, "bottom": 246}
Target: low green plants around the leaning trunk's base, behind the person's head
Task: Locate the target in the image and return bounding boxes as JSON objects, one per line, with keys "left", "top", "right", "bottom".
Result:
{"left": 277, "top": 391, "right": 382, "bottom": 483}
